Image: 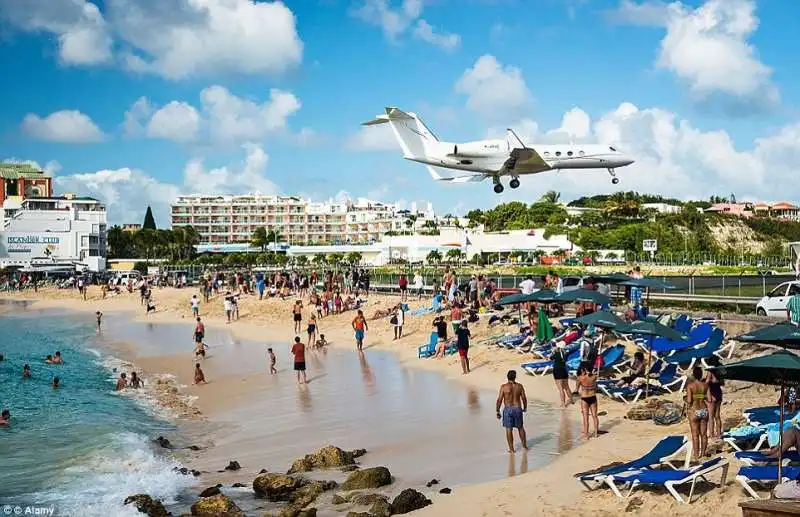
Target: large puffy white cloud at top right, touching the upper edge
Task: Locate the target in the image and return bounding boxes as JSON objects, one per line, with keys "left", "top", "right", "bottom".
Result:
{"left": 616, "top": 0, "right": 780, "bottom": 112}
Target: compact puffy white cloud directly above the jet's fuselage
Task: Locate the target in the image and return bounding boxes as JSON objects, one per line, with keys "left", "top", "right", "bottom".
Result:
{"left": 455, "top": 54, "right": 532, "bottom": 119}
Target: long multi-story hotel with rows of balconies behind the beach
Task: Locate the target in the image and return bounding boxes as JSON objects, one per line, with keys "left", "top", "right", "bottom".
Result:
{"left": 171, "top": 195, "right": 433, "bottom": 245}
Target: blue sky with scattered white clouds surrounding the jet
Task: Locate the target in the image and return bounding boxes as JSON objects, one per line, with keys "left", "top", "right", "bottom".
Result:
{"left": 0, "top": 0, "right": 800, "bottom": 227}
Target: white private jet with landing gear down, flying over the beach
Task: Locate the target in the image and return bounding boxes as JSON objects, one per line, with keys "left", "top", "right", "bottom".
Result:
{"left": 362, "top": 107, "right": 634, "bottom": 194}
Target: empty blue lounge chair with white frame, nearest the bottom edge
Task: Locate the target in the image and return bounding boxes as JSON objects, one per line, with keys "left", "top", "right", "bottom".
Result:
{"left": 604, "top": 458, "right": 728, "bottom": 504}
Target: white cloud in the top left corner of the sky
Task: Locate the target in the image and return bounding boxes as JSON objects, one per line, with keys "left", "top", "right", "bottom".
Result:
{"left": 0, "top": 0, "right": 112, "bottom": 65}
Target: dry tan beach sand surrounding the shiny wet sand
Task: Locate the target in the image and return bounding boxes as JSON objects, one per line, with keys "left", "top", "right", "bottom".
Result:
{"left": 5, "top": 286, "right": 777, "bottom": 517}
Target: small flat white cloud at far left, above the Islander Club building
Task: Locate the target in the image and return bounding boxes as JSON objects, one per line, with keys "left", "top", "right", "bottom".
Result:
{"left": 21, "top": 110, "right": 104, "bottom": 144}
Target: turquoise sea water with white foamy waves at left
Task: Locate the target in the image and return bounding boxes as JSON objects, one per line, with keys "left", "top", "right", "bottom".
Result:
{"left": 0, "top": 312, "right": 191, "bottom": 516}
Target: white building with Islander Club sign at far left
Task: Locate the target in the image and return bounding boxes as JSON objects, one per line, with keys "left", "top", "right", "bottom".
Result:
{"left": 0, "top": 194, "right": 107, "bottom": 271}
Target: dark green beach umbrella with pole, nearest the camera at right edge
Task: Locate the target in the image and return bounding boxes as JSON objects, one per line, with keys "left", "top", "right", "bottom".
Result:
{"left": 711, "top": 348, "right": 800, "bottom": 482}
